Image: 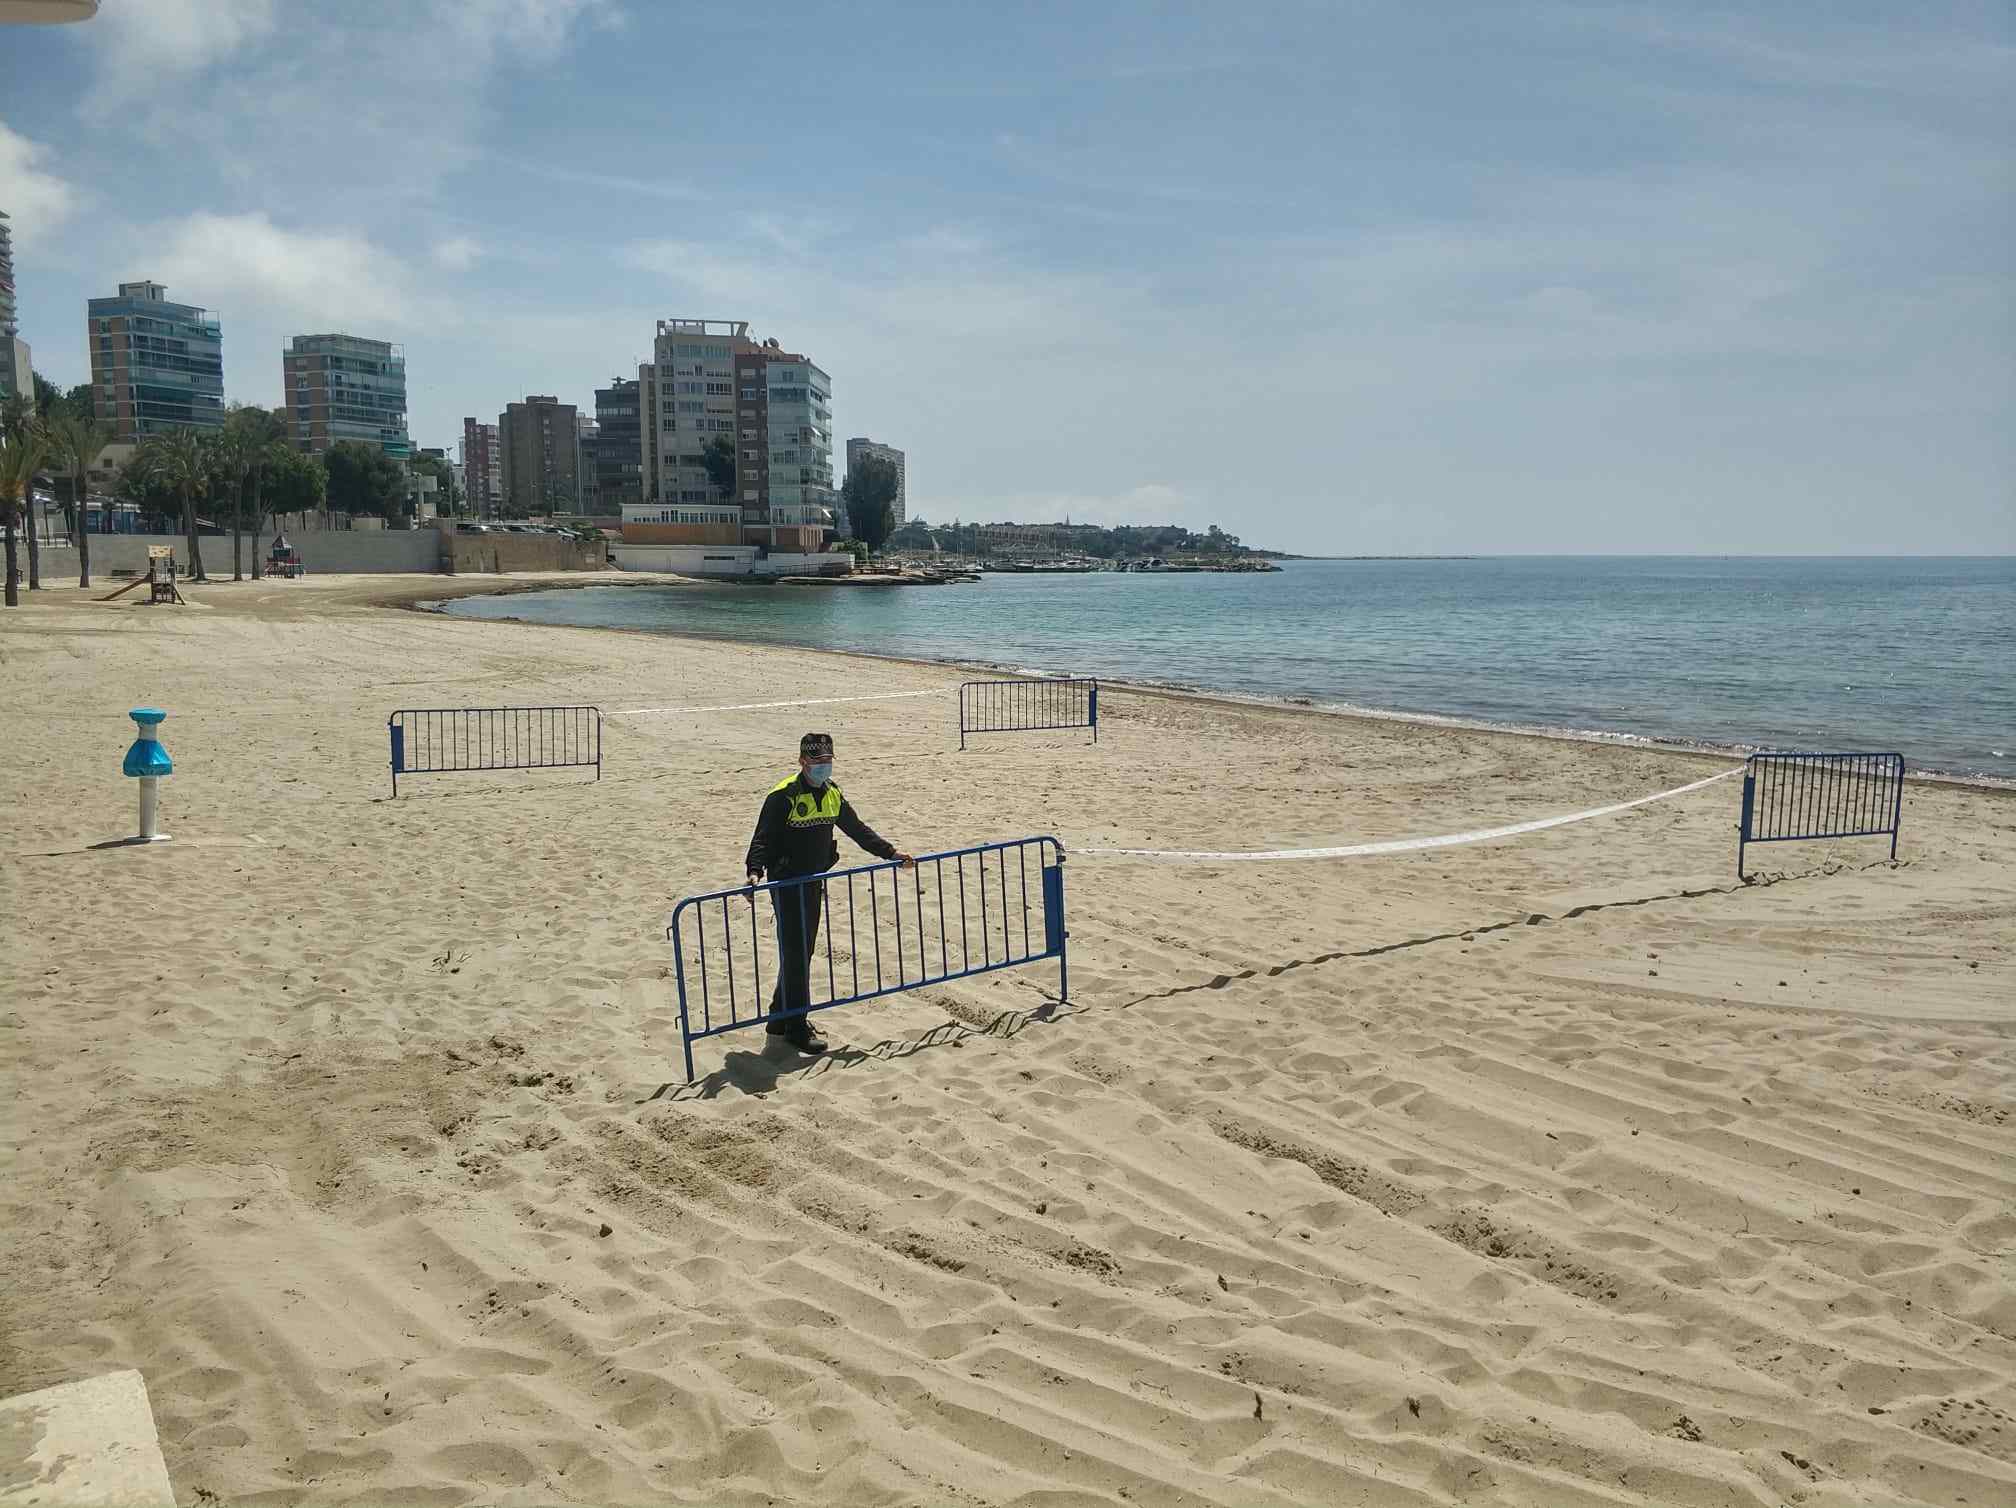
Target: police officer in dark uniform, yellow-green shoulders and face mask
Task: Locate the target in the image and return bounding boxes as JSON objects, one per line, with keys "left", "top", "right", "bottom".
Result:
{"left": 742, "top": 734, "right": 917, "bottom": 1052}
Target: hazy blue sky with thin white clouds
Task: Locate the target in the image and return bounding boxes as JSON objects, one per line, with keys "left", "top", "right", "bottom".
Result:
{"left": 0, "top": 0, "right": 2016, "bottom": 554}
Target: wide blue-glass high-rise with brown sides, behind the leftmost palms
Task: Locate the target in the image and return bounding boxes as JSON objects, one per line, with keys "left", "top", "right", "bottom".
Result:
{"left": 85, "top": 282, "right": 224, "bottom": 444}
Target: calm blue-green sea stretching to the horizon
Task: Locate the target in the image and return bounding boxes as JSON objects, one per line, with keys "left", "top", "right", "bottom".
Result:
{"left": 448, "top": 556, "right": 2016, "bottom": 778}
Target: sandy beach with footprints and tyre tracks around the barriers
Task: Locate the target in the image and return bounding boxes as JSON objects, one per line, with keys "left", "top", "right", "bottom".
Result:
{"left": 0, "top": 579, "right": 2016, "bottom": 1508}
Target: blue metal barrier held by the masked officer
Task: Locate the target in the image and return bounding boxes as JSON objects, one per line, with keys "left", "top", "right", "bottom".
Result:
{"left": 665, "top": 837, "right": 1070, "bottom": 1083}
